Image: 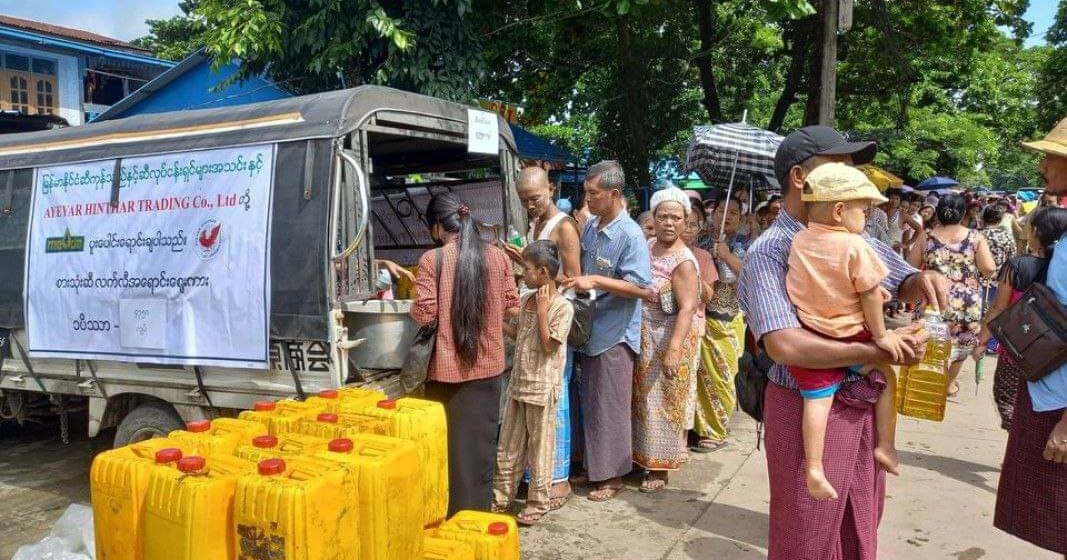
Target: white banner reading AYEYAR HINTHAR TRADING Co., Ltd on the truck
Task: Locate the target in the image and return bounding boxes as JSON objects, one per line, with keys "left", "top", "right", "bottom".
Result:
{"left": 25, "top": 145, "right": 274, "bottom": 368}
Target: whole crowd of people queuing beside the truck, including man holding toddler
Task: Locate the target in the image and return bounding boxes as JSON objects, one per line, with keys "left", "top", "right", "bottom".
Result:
{"left": 412, "top": 119, "right": 1067, "bottom": 559}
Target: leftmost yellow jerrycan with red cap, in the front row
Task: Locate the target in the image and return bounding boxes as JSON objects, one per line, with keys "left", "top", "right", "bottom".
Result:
{"left": 89, "top": 437, "right": 187, "bottom": 560}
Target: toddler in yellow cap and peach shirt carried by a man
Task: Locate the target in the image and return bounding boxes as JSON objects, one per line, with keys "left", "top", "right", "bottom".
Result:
{"left": 785, "top": 163, "right": 906, "bottom": 499}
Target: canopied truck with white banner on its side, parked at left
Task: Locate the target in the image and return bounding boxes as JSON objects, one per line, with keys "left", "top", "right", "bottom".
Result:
{"left": 0, "top": 86, "right": 526, "bottom": 447}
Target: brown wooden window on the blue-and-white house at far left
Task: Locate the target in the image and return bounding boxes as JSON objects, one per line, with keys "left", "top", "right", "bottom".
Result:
{"left": 0, "top": 52, "right": 59, "bottom": 115}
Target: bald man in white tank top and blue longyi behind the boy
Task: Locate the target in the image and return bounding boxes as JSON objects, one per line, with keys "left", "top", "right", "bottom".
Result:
{"left": 504, "top": 167, "right": 582, "bottom": 503}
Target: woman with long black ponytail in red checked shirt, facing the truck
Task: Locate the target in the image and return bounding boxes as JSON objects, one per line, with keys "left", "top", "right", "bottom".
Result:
{"left": 411, "top": 193, "right": 519, "bottom": 509}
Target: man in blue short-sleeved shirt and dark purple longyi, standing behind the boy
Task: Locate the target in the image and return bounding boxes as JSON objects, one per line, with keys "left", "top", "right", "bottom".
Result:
{"left": 563, "top": 161, "right": 652, "bottom": 501}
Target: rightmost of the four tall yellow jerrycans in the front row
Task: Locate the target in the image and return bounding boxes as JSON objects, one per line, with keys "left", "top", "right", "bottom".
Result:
{"left": 316, "top": 434, "right": 426, "bottom": 560}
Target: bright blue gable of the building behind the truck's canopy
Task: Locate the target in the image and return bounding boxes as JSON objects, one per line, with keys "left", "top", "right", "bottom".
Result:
{"left": 114, "top": 61, "right": 291, "bottom": 118}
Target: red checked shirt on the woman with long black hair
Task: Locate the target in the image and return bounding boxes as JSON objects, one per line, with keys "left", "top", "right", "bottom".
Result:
{"left": 411, "top": 240, "right": 519, "bottom": 383}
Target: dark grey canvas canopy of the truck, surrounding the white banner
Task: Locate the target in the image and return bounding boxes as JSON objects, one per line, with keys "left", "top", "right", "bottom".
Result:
{"left": 0, "top": 86, "right": 515, "bottom": 340}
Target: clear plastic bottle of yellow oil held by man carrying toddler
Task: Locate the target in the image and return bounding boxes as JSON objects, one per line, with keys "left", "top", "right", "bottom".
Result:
{"left": 896, "top": 307, "right": 952, "bottom": 421}
